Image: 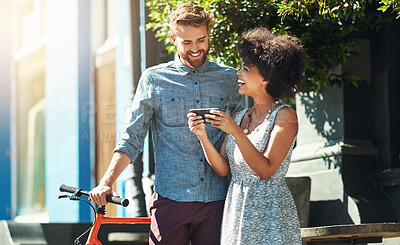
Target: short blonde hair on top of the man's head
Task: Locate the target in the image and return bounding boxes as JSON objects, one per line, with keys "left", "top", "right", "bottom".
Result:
{"left": 170, "top": 3, "right": 214, "bottom": 36}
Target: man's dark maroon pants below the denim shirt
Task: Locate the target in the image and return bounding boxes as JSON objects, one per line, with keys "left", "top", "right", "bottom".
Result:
{"left": 149, "top": 193, "right": 224, "bottom": 245}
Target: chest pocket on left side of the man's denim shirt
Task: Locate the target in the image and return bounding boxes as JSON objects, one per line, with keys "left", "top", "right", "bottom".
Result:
{"left": 160, "top": 97, "right": 189, "bottom": 127}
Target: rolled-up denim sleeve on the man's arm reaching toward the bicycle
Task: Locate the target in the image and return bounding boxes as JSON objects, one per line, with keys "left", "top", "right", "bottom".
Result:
{"left": 114, "top": 71, "right": 155, "bottom": 162}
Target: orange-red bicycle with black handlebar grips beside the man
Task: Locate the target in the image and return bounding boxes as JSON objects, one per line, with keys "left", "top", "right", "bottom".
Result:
{"left": 58, "top": 185, "right": 150, "bottom": 245}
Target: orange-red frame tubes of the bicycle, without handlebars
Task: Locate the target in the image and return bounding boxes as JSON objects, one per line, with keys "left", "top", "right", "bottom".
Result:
{"left": 86, "top": 206, "right": 150, "bottom": 245}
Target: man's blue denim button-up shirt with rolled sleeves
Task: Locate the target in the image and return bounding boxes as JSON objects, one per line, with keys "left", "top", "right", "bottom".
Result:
{"left": 114, "top": 55, "right": 241, "bottom": 202}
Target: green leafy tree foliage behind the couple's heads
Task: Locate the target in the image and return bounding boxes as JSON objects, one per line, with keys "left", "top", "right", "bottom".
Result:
{"left": 146, "top": 0, "right": 400, "bottom": 91}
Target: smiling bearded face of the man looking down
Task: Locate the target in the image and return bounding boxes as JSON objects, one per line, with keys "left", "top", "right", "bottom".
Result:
{"left": 171, "top": 25, "right": 209, "bottom": 69}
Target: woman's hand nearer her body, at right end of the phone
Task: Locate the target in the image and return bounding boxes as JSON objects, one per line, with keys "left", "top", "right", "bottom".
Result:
{"left": 205, "top": 110, "right": 240, "bottom": 135}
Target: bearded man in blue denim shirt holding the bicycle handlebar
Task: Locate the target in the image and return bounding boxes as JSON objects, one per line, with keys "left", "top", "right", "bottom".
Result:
{"left": 90, "top": 3, "right": 241, "bottom": 245}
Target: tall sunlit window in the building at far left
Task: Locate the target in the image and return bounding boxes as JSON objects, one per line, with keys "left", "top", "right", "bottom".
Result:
{"left": 13, "top": 0, "right": 45, "bottom": 221}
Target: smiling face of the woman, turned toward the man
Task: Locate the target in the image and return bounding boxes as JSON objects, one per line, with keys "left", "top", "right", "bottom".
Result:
{"left": 237, "top": 64, "right": 267, "bottom": 97}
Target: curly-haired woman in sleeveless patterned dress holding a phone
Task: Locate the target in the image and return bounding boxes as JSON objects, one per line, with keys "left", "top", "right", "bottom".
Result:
{"left": 188, "top": 28, "right": 304, "bottom": 245}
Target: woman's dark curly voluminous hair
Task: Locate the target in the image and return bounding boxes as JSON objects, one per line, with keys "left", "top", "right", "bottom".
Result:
{"left": 238, "top": 27, "right": 305, "bottom": 98}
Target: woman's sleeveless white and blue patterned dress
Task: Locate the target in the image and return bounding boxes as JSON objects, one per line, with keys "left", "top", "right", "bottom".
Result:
{"left": 221, "top": 105, "right": 301, "bottom": 245}
